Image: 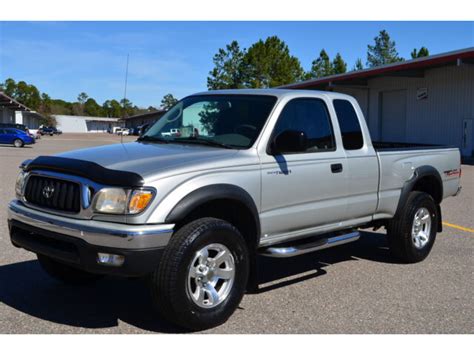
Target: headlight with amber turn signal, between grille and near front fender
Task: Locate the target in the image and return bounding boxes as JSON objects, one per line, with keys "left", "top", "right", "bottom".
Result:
{"left": 93, "top": 187, "right": 154, "bottom": 214}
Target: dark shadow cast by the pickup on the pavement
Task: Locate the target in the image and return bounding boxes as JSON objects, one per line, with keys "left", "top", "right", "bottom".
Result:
{"left": 0, "top": 232, "right": 393, "bottom": 333}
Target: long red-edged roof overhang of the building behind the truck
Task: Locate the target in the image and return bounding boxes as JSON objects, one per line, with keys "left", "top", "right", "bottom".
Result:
{"left": 281, "top": 47, "right": 474, "bottom": 89}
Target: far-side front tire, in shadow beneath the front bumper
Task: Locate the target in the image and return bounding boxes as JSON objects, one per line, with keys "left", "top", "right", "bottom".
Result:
{"left": 37, "top": 254, "right": 103, "bottom": 285}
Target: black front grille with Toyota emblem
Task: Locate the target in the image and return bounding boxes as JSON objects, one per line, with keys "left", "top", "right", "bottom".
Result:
{"left": 25, "top": 175, "right": 81, "bottom": 213}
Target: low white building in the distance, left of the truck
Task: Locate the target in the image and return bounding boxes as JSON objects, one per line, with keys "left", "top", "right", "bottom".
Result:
{"left": 52, "top": 115, "right": 123, "bottom": 133}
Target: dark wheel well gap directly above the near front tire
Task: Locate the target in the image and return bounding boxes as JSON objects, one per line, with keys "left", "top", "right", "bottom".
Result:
{"left": 176, "top": 198, "right": 259, "bottom": 252}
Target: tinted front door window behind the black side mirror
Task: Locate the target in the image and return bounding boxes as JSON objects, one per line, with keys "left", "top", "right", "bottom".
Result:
{"left": 273, "top": 98, "right": 336, "bottom": 153}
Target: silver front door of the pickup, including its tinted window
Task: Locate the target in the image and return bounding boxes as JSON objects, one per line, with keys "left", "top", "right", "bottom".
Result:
{"left": 260, "top": 97, "right": 347, "bottom": 241}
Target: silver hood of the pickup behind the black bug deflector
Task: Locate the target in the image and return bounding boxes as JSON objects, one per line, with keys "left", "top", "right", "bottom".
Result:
{"left": 56, "top": 142, "right": 238, "bottom": 180}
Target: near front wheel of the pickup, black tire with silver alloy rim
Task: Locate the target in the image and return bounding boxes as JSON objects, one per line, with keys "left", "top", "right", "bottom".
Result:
{"left": 150, "top": 218, "right": 249, "bottom": 330}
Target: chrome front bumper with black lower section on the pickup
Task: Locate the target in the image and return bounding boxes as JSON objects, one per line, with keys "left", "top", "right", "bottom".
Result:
{"left": 8, "top": 200, "right": 174, "bottom": 276}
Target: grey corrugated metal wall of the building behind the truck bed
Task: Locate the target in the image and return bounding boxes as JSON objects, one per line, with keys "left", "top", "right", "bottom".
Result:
{"left": 335, "top": 64, "right": 474, "bottom": 156}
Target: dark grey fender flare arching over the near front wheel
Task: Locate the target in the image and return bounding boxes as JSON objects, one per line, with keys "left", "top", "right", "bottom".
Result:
{"left": 165, "top": 184, "right": 260, "bottom": 242}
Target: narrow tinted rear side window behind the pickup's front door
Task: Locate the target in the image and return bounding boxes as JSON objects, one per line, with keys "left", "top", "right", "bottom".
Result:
{"left": 333, "top": 100, "right": 364, "bottom": 150}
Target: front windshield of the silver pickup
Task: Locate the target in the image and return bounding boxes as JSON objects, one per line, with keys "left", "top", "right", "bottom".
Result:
{"left": 140, "top": 95, "right": 276, "bottom": 149}
